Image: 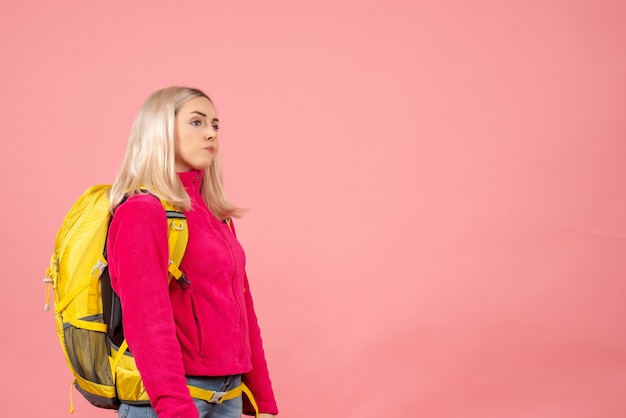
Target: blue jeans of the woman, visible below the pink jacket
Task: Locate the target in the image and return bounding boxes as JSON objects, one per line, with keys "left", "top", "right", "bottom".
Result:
{"left": 117, "top": 375, "right": 242, "bottom": 418}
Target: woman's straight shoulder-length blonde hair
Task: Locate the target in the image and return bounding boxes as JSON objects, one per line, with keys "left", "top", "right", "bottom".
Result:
{"left": 110, "top": 86, "right": 242, "bottom": 220}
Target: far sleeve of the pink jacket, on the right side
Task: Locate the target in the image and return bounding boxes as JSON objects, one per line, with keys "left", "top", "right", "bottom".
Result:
{"left": 230, "top": 222, "right": 278, "bottom": 415}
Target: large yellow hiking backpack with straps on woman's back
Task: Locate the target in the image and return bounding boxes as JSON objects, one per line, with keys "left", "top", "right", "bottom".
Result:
{"left": 44, "top": 184, "right": 258, "bottom": 415}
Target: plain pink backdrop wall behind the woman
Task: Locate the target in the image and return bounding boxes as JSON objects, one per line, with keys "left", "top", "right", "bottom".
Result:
{"left": 0, "top": 0, "right": 626, "bottom": 418}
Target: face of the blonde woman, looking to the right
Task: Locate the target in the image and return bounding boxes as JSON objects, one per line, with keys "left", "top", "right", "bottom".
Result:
{"left": 174, "top": 97, "right": 219, "bottom": 172}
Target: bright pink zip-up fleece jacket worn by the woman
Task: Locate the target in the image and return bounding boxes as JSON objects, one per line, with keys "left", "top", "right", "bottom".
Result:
{"left": 107, "top": 171, "right": 278, "bottom": 418}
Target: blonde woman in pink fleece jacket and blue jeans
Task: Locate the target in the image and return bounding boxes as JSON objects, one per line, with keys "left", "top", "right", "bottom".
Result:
{"left": 107, "top": 87, "right": 278, "bottom": 418}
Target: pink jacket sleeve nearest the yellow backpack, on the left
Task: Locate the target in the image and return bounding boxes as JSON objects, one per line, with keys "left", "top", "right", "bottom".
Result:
{"left": 108, "top": 195, "right": 198, "bottom": 418}
